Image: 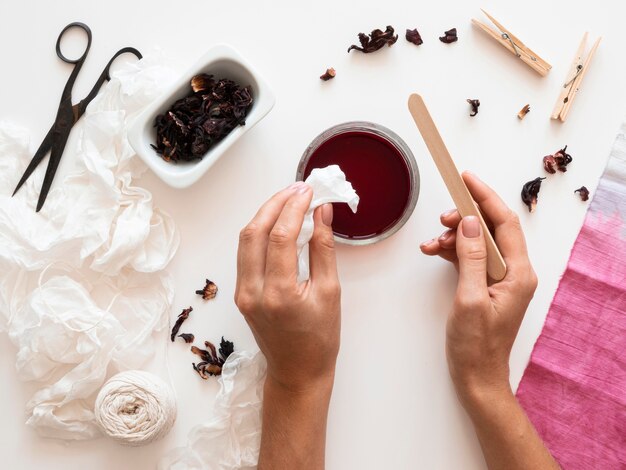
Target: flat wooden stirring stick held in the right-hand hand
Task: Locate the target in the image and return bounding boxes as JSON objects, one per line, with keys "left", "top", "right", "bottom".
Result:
{"left": 409, "top": 93, "right": 506, "bottom": 281}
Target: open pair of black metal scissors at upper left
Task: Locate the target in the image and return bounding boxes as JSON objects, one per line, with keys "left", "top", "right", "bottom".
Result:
{"left": 13, "top": 22, "right": 142, "bottom": 212}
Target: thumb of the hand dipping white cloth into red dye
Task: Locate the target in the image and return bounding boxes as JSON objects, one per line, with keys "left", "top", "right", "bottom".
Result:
{"left": 309, "top": 204, "right": 337, "bottom": 282}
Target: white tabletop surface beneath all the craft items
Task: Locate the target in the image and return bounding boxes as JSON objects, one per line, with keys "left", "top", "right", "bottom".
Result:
{"left": 0, "top": 0, "right": 626, "bottom": 470}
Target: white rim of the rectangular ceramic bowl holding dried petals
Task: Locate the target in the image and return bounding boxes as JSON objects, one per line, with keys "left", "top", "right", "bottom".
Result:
{"left": 128, "top": 43, "right": 275, "bottom": 188}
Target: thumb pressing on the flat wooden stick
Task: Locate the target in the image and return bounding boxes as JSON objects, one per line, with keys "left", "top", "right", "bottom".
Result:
{"left": 456, "top": 215, "right": 487, "bottom": 298}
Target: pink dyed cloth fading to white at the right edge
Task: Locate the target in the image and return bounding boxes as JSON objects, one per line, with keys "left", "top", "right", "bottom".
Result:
{"left": 517, "top": 123, "right": 626, "bottom": 470}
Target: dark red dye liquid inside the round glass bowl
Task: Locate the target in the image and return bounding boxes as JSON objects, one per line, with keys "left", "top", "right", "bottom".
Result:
{"left": 304, "top": 131, "right": 411, "bottom": 239}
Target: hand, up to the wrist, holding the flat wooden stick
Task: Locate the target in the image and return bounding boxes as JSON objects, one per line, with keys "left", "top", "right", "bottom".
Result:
{"left": 420, "top": 172, "right": 537, "bottom": 406}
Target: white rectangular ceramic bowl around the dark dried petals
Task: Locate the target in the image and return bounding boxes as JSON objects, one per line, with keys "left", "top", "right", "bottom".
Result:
{"left": 128, "top": 44, "right": 275, "bottom": 188}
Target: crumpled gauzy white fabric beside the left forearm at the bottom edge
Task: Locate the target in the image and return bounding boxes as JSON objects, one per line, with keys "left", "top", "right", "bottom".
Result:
{"left": 159, "top": 351, "right": 267, "bottom": 470}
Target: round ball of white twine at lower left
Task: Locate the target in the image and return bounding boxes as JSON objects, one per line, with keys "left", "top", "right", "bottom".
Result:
{"left": 94, "top": 370, "right": 176, "bottom": 446}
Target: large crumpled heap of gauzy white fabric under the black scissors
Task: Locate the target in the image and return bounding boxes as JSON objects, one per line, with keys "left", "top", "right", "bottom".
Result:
{"left": 0, "top": 57, "right": 179, "bottom": 439}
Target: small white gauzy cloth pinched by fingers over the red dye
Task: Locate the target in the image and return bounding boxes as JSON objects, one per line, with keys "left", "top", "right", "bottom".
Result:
{"left": 296, "top": 165, "right": 359, "bottom": 282}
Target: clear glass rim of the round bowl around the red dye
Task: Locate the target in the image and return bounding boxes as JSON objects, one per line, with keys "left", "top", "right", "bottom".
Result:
{"left": 296, "top": 121, "right": 420, "bottom": 246}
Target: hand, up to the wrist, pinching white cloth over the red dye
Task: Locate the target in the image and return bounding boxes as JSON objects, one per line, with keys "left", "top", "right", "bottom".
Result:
{"left": 235, "top": 182, "right": 341, "bottom": 393}
